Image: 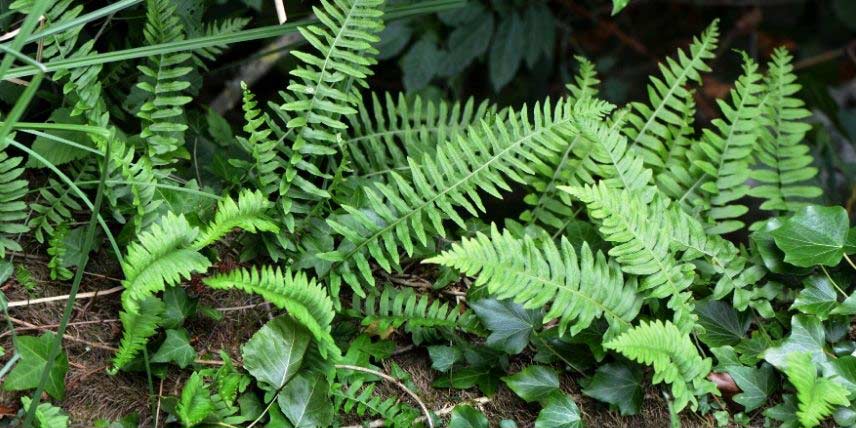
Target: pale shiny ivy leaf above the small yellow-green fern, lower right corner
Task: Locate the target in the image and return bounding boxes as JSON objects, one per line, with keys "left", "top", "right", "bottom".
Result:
{"left": 764, "top": 315, "right": 826, "bottom": 370}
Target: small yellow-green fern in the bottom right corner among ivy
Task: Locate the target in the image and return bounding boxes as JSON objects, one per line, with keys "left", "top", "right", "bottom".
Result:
{"left": 785, "top": 352, "right": 850, "bottom": 427}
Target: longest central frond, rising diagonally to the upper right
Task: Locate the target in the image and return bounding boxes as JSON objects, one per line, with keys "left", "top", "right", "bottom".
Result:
{"left": 326, "top": 101, "right": 572, "bottom": 295}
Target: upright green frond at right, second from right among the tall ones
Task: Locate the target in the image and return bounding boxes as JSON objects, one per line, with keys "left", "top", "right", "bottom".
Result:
{"left": 677, "top": 55, "right": 763, "bottom": 234}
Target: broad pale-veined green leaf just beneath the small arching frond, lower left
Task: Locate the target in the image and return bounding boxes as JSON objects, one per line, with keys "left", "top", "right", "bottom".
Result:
{"left": 241, "top": 315, "right": 311, "bottom": 391}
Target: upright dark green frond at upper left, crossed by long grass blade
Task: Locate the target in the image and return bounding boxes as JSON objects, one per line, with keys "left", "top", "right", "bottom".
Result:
{"left": 137, "top": 0, "right": 193, "bottom": 165}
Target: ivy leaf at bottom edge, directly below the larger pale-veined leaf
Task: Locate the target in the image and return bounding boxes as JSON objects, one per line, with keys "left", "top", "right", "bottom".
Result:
{"left": 276, "top": 374, "right": 333, "bottom": 428}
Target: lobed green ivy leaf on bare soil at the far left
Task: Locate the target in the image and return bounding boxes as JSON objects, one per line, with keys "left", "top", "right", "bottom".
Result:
{"left": 3, "top": 332, "right": 68, "bottom": 400}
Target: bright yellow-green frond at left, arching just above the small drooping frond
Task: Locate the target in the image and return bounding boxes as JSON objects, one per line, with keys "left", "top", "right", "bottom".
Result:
{"left": 122, "top": 212, "right": 211, "bottom": 302}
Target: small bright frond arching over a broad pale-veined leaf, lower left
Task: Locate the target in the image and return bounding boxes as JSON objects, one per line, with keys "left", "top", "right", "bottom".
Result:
{"left": 203, "top": 267, "right": 341, "bottom": 359}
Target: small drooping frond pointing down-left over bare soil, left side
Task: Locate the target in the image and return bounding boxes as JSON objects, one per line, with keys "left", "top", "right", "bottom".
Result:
{"left": 110, "top": 296, "right": 166, "bottom": 374}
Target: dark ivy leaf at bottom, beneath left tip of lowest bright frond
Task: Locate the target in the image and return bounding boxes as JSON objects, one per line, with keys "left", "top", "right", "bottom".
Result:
{"left": 582, "top": 361, "right": 643, "bottom": 415}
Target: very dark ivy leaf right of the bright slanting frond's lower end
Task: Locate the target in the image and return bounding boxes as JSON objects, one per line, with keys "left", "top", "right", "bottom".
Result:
{"left": 696, "top": 301, "right": 752, "bottom": 347}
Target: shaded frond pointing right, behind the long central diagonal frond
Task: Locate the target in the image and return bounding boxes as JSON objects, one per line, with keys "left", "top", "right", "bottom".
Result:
{"left": 347, "top": 93, "right": 497, "bottom": 176}
